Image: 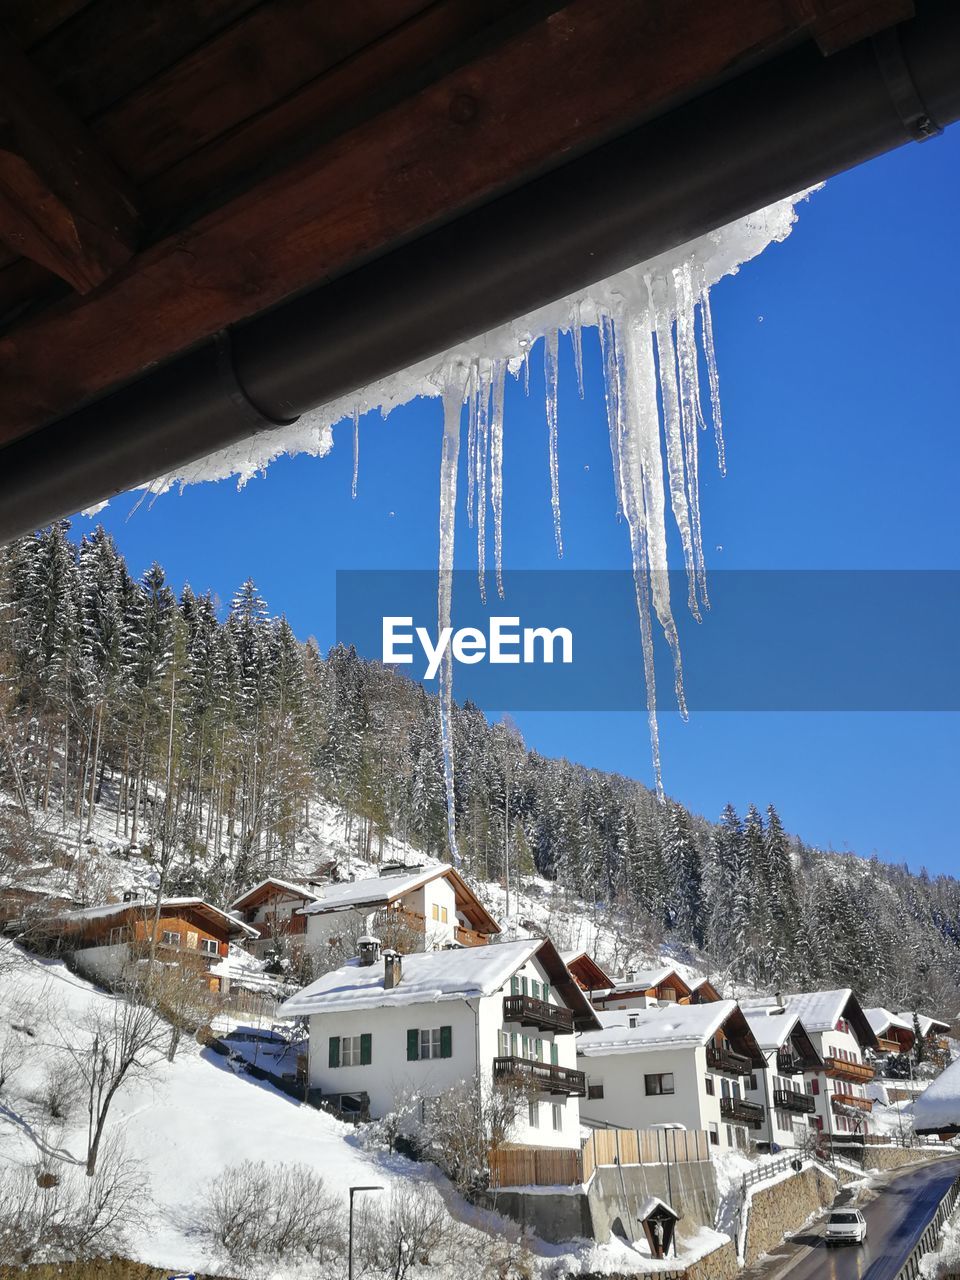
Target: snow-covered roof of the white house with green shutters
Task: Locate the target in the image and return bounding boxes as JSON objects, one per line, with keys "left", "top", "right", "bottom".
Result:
{"left": 279, "top": 938, "right": 596, "bottom": 1025}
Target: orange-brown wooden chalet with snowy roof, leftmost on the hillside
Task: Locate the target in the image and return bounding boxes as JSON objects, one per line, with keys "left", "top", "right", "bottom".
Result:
{"left": 49, "top": 897, "right": 257, "bottom": 993}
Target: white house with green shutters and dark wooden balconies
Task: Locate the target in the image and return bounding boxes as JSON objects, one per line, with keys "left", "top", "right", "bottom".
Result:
{"left": 280, "top": 938, "right": 599, "bottom": 1148}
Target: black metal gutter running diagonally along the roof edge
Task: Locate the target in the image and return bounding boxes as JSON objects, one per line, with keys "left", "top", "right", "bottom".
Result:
{"left": 0, "top": 0, "right": 960, "bottom": 543}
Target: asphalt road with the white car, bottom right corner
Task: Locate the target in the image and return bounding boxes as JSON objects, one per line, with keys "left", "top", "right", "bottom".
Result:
{"left": 763, "top": 1160, "right": 960, "bottom": 1280}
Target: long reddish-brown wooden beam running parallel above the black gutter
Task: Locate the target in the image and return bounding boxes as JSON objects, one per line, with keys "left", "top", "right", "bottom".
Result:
{"left": 0, "top": 0, "right": 885, "bottom": 443}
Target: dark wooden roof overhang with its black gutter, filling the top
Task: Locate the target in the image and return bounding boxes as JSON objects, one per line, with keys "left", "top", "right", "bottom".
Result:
{"left": 0, "top": 0, "right": 960, "bottom": 541}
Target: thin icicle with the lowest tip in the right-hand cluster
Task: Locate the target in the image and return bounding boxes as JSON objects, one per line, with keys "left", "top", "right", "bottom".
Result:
{"left": 599, "top": 304, "right": 664, "bottom": 801}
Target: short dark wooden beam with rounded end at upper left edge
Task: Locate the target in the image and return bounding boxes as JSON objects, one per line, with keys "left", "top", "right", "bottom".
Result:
{"left": 0, "top": 33, "right": 137, "bottom": 293}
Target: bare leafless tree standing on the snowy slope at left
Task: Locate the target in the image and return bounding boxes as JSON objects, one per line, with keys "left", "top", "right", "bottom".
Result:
{"left": 67, "top": 991, "right": 169, "bottom": 1178}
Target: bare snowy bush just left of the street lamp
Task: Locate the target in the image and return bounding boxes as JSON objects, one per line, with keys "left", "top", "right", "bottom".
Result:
{"left": 197, "top": 1160, "right": 344, "bottom": 1263}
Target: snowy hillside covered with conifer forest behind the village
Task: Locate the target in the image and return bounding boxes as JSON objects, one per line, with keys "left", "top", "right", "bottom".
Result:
{"left": 0, "top": 525, "right": 960, "bottom": 1011}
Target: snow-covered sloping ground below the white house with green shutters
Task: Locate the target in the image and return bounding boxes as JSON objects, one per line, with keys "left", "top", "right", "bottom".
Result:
{"left": 0, "top": 943, "right": 722, "bottom": 1280}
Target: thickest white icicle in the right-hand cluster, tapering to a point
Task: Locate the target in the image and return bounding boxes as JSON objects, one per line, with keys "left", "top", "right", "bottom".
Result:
{"left": 620, "top": 293, "right": 687, "bottom": 719}
